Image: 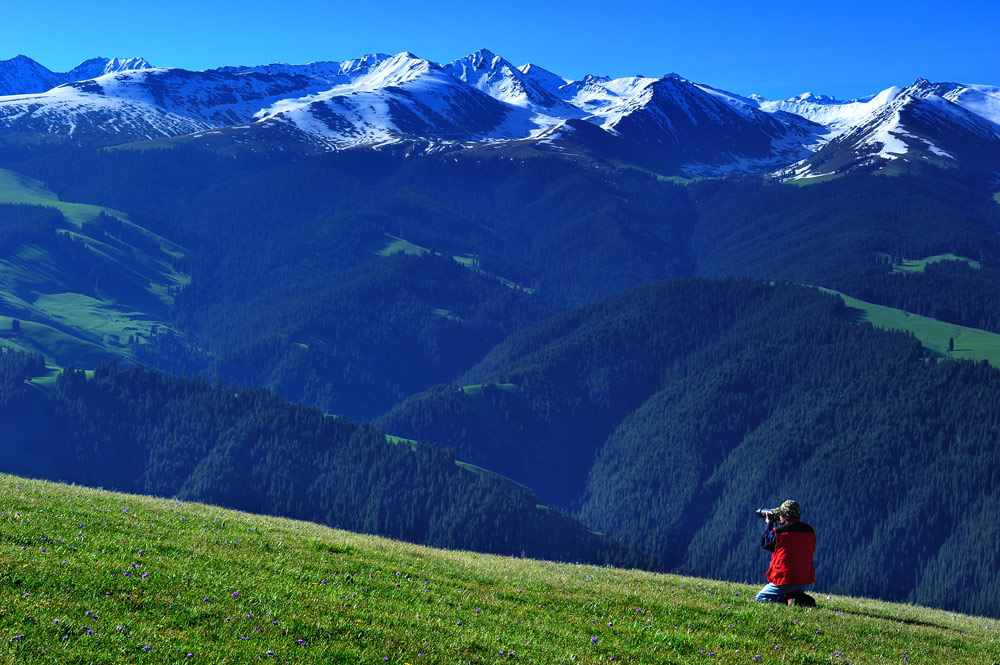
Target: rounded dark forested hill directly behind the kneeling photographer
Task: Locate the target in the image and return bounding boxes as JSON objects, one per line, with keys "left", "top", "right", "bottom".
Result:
{"left": 377, "top": 280, "right": 1000, "bottom": 612}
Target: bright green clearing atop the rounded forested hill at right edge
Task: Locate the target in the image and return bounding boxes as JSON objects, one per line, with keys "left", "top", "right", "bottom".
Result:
{"left": 820, "top": 289, "right": 1000, "bottom": 367}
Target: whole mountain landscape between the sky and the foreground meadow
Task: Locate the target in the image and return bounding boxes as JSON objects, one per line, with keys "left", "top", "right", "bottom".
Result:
{"left": 0, "top": 50, "right": 1000, "bottom": 616}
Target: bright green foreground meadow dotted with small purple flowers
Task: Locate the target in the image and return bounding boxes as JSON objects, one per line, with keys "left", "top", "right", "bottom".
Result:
{"left": 0, "top": 476, "right": 1000, "bottom": 665}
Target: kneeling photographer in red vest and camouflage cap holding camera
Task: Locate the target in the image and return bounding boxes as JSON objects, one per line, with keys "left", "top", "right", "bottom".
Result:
{"left": 757, "top": 500, "right": 816, "bottom": 605}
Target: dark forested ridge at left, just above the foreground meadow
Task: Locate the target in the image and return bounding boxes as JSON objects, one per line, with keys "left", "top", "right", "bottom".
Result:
{"left": 0, "top": 352, "right": 650, "bottom": 567}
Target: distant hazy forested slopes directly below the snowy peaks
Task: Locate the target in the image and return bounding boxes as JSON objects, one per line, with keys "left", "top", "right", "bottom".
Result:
{"left": 7, "top": 146, "right": 1000, "bottom": 419}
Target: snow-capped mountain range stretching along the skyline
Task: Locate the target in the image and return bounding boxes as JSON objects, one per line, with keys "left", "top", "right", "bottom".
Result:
{"left": 0, "top": 49, "right": 1000, "bottom": 177}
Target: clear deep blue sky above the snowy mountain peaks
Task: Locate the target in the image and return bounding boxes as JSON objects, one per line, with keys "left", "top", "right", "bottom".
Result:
{"left": 0, "top": 0, "right": 1000, "bottom": 99}
